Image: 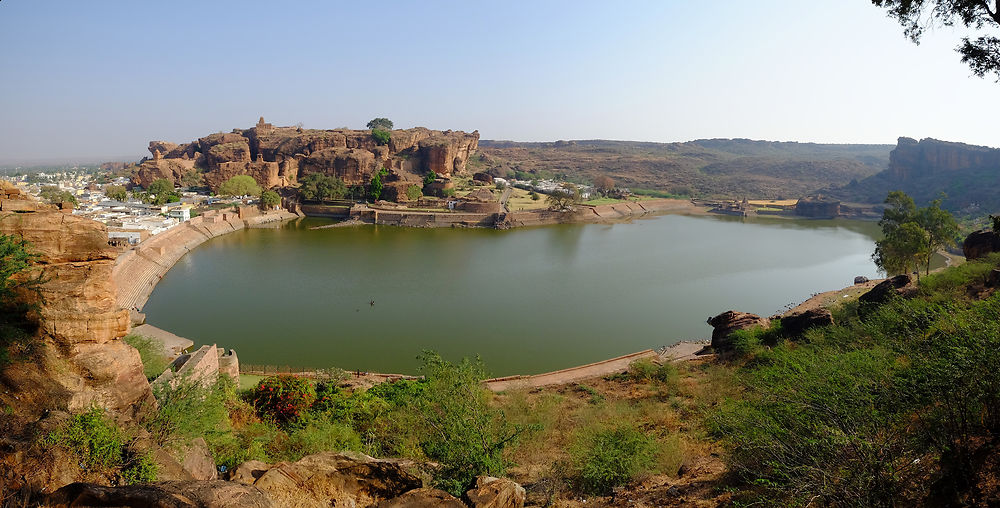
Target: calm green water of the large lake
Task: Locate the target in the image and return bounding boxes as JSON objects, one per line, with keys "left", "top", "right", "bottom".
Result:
{"left": 144, "top": 215, "right": 879, "bottom": 375}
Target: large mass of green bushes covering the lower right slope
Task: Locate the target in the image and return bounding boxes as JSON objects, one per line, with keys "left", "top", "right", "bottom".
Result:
{"left": 711, "top": 252, "right": 1000, "bottom": 506}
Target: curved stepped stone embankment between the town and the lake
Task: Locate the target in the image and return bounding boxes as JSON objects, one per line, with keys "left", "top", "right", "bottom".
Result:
{"left": 111, "top": 206, "right": 298, "bottom": 310}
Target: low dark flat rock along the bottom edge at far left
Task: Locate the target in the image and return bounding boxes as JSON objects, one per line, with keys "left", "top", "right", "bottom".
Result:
{"left": 45, "top": 480, "right": 272, "bottom": 508}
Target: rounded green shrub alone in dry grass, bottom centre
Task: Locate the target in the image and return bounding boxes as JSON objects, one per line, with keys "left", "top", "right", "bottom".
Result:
{"left": 570, "top": 426, "right": 658, "bottom": 495}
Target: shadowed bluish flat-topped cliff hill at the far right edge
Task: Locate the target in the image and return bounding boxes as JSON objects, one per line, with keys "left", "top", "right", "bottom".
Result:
{"left": 828, "top": 137, "right": 1000, "bottom": 216}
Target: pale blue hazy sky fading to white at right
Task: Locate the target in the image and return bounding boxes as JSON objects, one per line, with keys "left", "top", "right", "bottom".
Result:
{"left": 0, "top": 0, "right": 1000, "bottom": 162}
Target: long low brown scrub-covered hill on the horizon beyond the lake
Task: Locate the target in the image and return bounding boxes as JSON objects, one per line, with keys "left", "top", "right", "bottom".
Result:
{"left": 470, "top": 139, "right": 892, "bottom": 198}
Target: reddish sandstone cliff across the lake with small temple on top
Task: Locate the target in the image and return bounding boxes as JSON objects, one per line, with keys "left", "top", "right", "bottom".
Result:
{"left": 132, "top": 118, "right": 479, "bottom": 194}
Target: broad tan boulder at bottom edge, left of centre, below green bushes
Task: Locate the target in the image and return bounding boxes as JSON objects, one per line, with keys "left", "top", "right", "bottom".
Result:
{"left": 232, "top": 452, "right": 423, "bottom": 508}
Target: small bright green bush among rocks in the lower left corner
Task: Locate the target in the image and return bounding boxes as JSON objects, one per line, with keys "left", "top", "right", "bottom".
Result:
{"left": 45, "top": 408, "right": 157, "bottom": 484}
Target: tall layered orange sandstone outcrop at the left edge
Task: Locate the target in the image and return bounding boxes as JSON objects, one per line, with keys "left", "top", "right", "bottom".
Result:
{"left": 0, "top": 189, "right": 152, "bottom": 417}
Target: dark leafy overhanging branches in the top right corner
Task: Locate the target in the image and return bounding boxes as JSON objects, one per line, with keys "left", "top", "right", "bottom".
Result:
{"left": 872, "top": 0, "right": 1000, "bottom": 82}
